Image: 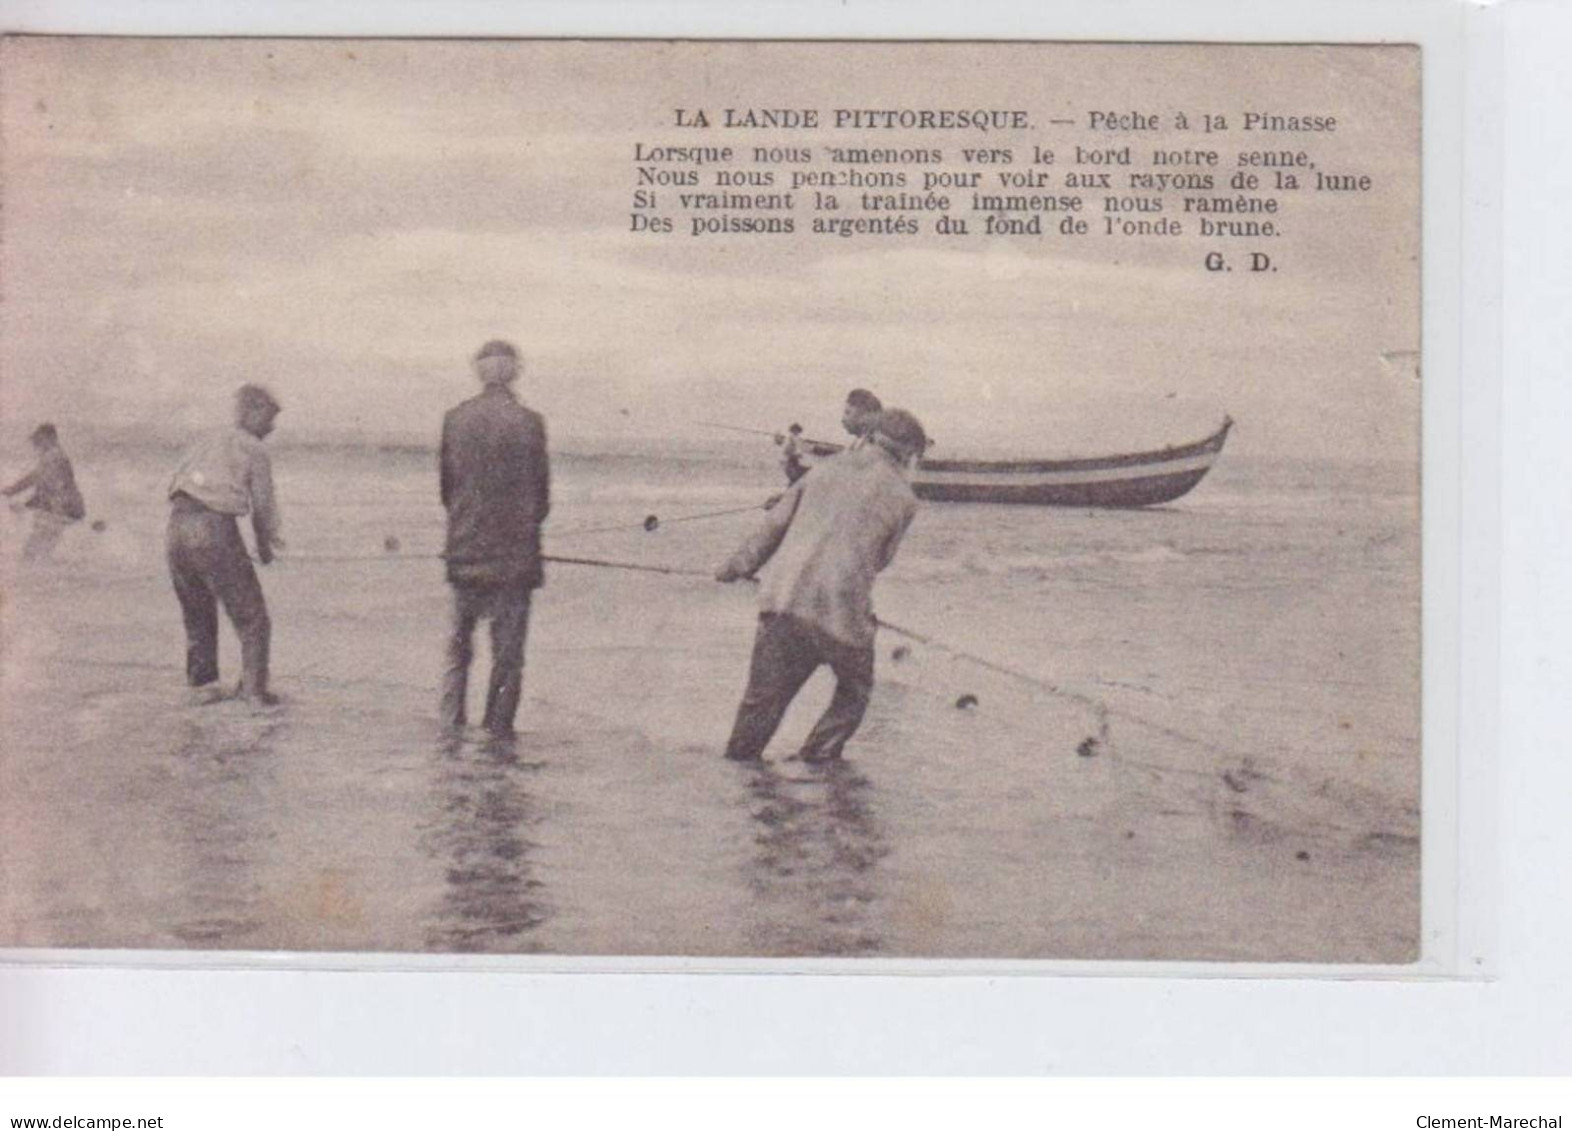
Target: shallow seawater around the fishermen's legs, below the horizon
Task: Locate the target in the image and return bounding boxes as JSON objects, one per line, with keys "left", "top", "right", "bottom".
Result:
{"left": 0, "top": 450, "right": 1420, "bottom": 961}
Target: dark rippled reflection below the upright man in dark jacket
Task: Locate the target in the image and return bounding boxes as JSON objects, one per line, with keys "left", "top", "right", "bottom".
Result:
{"left": 421, "top": 738, "right": 550, "bottom": 953}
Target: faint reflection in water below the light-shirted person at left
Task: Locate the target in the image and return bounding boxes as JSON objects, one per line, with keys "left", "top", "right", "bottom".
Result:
{"left": 168, "top": 717, "right": 285, "bottom": 947}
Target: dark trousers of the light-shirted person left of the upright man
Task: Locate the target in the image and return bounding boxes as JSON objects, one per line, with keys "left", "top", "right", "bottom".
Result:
{"left": 165, "top": 497, "right": 272, "bottom": 695}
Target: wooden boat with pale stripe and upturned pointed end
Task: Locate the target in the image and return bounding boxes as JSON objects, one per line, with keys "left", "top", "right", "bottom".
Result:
{"left": 912, "top": 417, "right": 1234, "bottom": 507}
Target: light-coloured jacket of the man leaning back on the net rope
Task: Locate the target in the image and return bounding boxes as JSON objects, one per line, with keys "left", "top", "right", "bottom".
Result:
{"left": 722, "top": 447, "right": 916, "bottom": 648}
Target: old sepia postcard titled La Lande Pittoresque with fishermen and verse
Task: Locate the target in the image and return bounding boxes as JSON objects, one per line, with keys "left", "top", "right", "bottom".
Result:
{"left": 0, "top": 38, "right": 1427, "bottom": 966}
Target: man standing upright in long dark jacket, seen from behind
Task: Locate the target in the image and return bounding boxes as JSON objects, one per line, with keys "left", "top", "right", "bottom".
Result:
{"left": 440, "top": 341, "right": 552, "bottom": 736}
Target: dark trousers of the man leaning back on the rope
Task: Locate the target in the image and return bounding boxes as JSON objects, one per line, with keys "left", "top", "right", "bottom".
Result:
{"left": 726, "top": 613, "right": 874, "bottom": 761}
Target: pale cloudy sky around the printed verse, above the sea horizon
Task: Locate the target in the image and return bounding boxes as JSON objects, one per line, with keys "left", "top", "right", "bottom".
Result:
{"left": 0, "top": 39, "right": 1420, "bottom": 459}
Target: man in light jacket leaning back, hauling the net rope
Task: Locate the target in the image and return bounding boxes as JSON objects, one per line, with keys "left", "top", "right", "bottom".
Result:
{"left": 715, "top": 409, "right": 927, "bottom": 761}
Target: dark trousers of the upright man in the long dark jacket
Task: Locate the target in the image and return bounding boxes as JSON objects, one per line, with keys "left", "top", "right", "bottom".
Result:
{"left": 440, "top": 579, "right": 533, "bottom": 735}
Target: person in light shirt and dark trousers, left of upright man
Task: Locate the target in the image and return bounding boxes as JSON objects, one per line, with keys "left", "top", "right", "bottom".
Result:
{"left": 167, "top": 385, "right": 285, "bottom": 705}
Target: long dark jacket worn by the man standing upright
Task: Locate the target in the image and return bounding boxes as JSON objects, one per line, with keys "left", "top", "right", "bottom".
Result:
{"left": 440, "top": 385, "right": 552, "bottom": 587}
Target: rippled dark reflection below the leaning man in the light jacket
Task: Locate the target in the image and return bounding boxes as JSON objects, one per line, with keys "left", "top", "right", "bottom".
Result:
{"left": 745, "top": 761, "right": 890, "bottom": 956}
